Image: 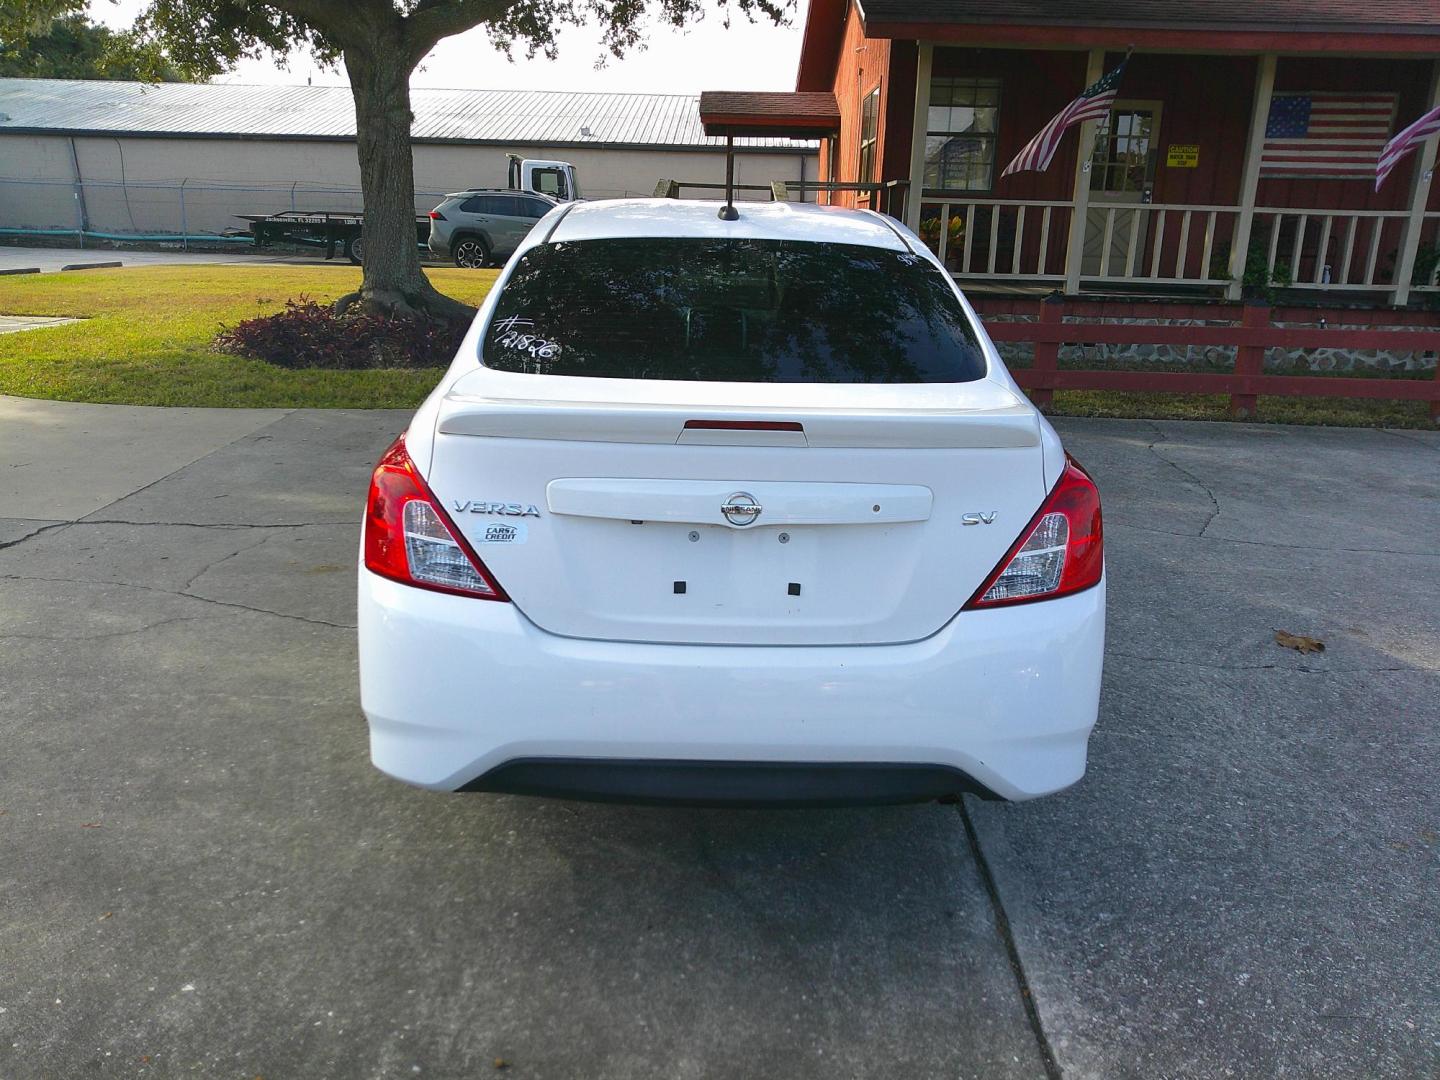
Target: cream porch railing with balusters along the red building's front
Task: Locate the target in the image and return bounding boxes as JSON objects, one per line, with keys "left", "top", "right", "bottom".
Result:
{"left": 920, "top": 199, "right": 1440, "bottom": 291}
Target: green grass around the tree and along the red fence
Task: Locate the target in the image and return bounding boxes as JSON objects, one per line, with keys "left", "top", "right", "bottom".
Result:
{"left": 0, "top": 265, "right": 1430, "bottom": 428}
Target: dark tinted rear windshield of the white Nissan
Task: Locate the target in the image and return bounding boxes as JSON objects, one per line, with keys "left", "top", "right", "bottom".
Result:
{"left": 481, "top": 238, "right": 985, "bottom": 383}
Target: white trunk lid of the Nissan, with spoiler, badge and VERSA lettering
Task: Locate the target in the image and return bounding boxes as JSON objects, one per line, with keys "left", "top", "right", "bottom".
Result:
{"left": 428, "top": 369, "right": 1044, "bottom": 645}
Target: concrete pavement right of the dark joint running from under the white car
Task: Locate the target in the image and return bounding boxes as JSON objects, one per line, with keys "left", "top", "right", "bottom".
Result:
{"left": 971, "top": 420, "right": 1440, "bottom": 1077}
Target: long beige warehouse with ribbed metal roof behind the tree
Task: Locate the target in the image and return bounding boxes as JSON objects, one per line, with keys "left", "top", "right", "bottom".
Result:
{"left": 0, "top": 79, "right": 816, "bottom": 235}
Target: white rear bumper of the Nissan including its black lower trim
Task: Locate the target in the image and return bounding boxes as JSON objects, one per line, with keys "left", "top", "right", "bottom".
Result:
{"left": 359, "top": 569, "right": 1104, "bottom": 804}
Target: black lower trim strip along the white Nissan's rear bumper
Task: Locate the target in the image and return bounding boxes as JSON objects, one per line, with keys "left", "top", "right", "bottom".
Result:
{"left": 459, "top": 757, "right": 1002, "bottom": 806}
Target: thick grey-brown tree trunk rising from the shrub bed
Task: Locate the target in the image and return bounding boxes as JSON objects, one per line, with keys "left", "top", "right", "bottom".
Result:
{"left": 337, "top": 42, "right": 475, "bottom": 320}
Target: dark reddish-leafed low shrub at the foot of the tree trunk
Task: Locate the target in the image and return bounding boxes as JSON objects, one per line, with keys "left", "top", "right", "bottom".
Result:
{"left": 215, "top": 297, "right": 465, "bottom": 369}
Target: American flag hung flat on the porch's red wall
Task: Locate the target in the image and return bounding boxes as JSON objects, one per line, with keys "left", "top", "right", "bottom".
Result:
{"left": 1260, "top": 91, "right": 1395, "bottom": 179}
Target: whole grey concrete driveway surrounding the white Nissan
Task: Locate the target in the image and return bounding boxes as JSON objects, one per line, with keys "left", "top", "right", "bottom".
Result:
{"left": 0, "top": 399, "right": 1440, "bottom": 1080}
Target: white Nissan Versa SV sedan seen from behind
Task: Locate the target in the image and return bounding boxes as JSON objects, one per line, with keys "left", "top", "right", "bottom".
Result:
{"left": 360, "top": 199, "right": 1104, "bottom": 805}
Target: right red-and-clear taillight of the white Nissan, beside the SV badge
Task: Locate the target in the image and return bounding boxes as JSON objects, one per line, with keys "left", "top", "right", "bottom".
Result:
{"left": 965, "top": 455, "right": 1104, "bottom": 611}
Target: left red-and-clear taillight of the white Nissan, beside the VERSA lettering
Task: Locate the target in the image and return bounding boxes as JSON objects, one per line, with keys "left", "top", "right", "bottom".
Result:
{"left": 364, "top": 435, "right": 510, "bottom": 600}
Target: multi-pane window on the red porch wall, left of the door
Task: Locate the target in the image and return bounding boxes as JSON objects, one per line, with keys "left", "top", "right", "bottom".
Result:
{"left": 924, "top": 75, "right": 999, "bottom": 192}
